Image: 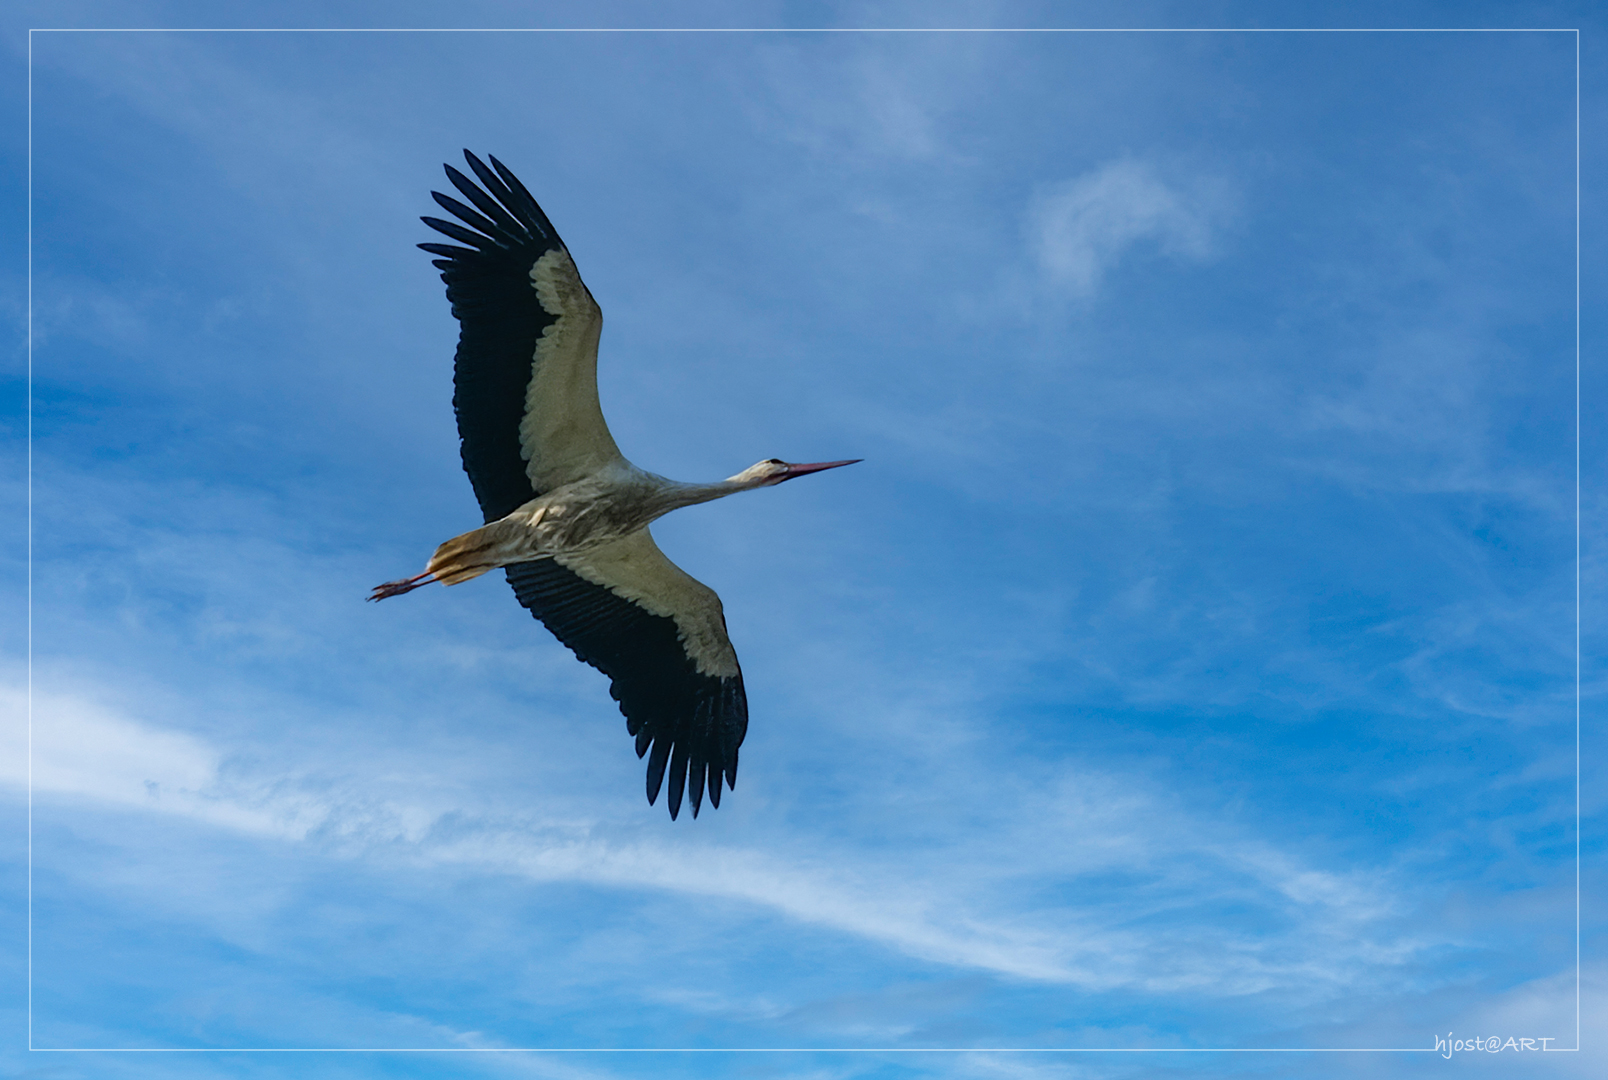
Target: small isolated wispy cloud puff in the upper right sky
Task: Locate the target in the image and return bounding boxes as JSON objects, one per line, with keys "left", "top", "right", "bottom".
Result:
{"left": 1028, "top": 158, "right": 1220, "bottom": 297}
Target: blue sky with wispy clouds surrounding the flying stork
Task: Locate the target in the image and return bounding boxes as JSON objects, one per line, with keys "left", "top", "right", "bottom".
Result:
{"left": 0, "top": 5, "right": 1608, "bottom": 1080}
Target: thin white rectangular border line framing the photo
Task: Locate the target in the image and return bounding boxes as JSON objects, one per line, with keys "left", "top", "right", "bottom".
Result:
{"left": 26, "top": 27, "right": 1581, "bottom": 1058}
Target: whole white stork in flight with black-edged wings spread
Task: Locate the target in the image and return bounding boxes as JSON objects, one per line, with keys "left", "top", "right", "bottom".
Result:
{"left": 370, "top": 151, "right": 854, "bottom": 818}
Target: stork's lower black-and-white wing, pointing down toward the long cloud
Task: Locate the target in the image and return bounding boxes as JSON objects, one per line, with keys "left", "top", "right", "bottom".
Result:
{"left": 507, "top": 529, "right": 748, "bottom": 818}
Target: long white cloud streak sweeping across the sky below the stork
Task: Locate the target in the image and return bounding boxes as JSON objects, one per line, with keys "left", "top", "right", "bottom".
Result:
{"left": 3, "top": 671, "right": 1413, "bottom": 993}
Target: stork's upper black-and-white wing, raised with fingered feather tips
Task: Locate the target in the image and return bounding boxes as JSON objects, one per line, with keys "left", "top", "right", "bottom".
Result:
{"left": 420, "top": 151, "right": 621, "bottom": 521}
